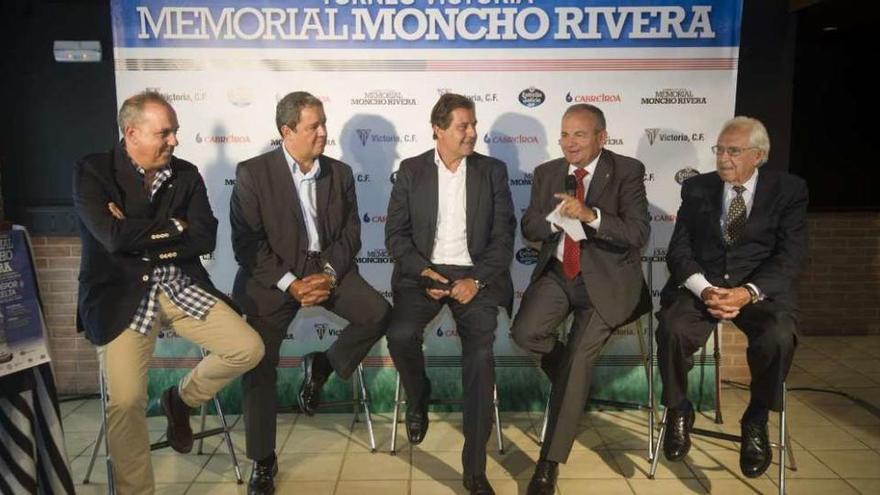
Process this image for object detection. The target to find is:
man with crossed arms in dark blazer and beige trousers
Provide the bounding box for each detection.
[73,92,263,494]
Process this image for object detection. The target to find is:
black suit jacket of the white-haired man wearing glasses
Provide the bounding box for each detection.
[662,170,808,309]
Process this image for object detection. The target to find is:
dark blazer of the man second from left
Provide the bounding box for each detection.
[229,146,361,315]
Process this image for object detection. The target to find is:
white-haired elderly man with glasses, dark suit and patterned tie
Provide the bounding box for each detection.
[657,117,807,477]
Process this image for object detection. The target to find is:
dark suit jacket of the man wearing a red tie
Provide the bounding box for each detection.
[522,149,651,327]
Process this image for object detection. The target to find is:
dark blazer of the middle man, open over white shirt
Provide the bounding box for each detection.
[385,149,516,313]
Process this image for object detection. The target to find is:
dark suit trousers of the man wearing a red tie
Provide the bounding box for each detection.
[511,260,613,462]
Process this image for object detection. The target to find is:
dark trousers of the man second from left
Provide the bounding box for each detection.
[242,269,391,460]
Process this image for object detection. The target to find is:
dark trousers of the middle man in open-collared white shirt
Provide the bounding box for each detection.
[387,266,498,477]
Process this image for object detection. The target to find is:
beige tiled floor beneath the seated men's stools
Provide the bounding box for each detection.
[62,336,880,495]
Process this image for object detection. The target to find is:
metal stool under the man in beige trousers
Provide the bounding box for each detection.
[83,348,244,495]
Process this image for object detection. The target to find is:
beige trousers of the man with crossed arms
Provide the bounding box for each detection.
[98,291,263,495]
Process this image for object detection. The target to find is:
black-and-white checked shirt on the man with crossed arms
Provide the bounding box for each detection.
[128,162,217,335]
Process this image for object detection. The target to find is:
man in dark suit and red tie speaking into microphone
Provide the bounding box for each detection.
[511,104,651,494]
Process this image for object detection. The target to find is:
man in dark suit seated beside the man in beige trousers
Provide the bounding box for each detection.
[230,92,390,494]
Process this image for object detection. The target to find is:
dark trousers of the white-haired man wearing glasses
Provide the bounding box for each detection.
[657,288,797,411]
